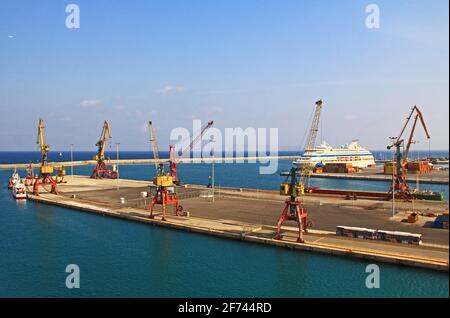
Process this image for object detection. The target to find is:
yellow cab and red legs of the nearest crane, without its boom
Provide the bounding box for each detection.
[275,167,312,243]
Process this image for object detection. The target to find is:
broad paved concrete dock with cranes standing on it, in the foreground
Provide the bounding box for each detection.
[25,176,449,271]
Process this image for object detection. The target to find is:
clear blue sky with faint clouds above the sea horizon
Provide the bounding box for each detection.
[0,0,449,150]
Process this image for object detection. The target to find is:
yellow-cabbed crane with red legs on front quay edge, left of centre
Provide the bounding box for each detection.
[148,121,183,221]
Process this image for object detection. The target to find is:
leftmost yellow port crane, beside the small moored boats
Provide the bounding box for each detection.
[30,118,57,195]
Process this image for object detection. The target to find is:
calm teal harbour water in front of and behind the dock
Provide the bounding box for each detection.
[0,152,449,297]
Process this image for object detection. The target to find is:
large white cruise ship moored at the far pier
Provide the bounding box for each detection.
[294,140,375,168]
